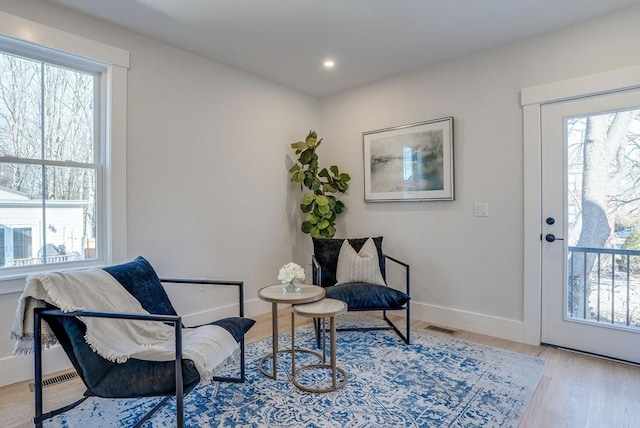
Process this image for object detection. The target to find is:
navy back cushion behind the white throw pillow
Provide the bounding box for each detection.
[312,236,386,287]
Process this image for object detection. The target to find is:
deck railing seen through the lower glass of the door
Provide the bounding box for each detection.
[567,247,640,329]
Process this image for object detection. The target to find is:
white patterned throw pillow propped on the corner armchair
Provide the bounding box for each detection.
[336,238,386,285]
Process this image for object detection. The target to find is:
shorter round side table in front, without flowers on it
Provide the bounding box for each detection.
[291,299,347,392]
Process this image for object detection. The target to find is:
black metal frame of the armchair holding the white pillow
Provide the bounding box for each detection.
[311,254,411,348]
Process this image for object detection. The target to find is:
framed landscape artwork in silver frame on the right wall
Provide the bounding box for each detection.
[362,117,454,202]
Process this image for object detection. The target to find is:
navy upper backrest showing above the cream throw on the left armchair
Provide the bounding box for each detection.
[104,257,177,315]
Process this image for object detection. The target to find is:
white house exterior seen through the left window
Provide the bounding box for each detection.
[0,187,95,268]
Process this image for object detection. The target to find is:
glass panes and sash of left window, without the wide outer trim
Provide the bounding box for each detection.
[0,46,104,268]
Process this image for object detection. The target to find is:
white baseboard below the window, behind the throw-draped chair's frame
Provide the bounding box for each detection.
[0,346,71,387]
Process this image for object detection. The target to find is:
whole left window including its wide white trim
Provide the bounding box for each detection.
[0,12,129,278]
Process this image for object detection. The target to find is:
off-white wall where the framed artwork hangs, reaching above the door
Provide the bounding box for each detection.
[320,7,640,341]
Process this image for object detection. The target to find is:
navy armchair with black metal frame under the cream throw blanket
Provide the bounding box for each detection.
[34,257,255,427]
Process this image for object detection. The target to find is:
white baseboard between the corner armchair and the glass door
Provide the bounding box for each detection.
[411,302,528,345]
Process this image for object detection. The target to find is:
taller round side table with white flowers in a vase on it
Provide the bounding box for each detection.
[258,284,324,379]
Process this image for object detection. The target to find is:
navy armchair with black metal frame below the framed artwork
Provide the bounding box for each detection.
[312,236,411,344]
